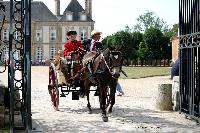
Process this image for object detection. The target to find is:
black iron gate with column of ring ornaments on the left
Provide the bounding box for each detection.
[0,0,32,133]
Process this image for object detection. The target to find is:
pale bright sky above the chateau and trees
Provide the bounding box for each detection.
[39,0,179,36]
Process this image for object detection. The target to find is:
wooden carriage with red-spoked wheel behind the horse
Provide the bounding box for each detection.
[48,53,84,110]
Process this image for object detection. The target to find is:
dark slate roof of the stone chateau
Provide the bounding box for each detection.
[0,0,94,22]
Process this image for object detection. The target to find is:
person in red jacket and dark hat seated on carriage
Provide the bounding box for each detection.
[64,31,84,57]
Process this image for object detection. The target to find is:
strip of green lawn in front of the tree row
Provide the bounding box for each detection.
[120,67,171,79]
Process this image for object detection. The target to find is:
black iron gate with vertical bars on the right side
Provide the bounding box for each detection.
[179,0,200,121]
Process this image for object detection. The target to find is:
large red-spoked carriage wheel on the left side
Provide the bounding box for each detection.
[48,63,59,111]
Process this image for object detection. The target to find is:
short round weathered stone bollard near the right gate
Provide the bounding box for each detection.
[156,84,172,111]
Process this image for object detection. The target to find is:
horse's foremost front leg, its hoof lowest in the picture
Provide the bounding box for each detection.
[99,87,108,122]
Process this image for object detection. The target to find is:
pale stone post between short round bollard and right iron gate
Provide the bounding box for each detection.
[172,76,180,111]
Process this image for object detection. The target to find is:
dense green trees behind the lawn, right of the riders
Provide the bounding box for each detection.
[102,11,179,64]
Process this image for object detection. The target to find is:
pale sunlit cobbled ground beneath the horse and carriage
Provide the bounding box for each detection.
[0,66,200,133]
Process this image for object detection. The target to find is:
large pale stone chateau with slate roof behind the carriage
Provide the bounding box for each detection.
[0,0,95,64]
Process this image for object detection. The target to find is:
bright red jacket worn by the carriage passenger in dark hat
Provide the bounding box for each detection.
[64,40,84,56]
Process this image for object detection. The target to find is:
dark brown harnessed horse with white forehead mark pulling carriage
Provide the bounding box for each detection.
[81,46,123,122]
